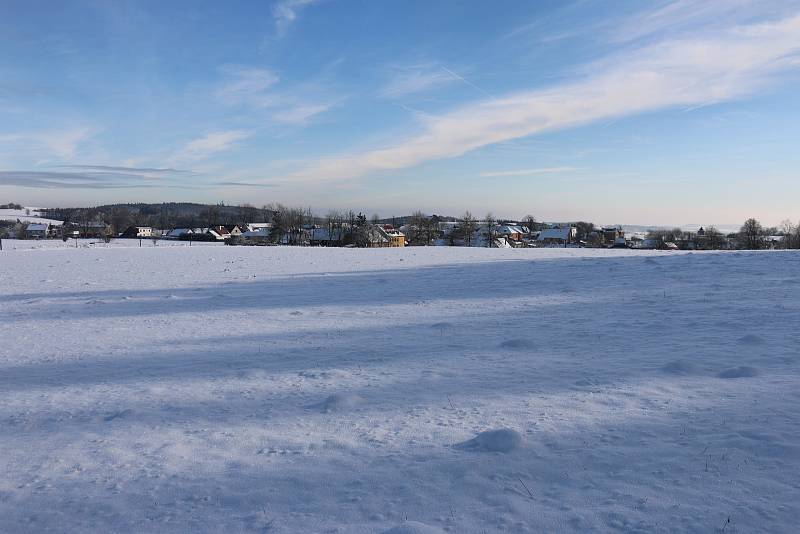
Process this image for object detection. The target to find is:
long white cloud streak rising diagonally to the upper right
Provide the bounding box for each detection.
[285,15,800,186]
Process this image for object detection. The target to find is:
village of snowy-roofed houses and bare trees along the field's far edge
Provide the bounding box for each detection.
[0,204,800,250]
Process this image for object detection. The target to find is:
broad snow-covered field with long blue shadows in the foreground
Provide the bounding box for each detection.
[0,247,800,533]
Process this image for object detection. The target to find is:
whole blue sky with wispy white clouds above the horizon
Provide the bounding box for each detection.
[0,0,800,224]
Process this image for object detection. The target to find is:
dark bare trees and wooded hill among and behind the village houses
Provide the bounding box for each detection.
[9,202,800,250]
